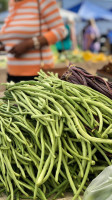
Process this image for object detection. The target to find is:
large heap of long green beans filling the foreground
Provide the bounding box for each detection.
[0,71,112,200]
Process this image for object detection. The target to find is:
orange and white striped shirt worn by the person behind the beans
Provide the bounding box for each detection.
[0,0,66,76]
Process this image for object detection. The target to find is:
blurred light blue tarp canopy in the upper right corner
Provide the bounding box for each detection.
[78,1,112,20]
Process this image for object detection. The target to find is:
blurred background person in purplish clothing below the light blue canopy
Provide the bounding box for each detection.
[83,19,100,52]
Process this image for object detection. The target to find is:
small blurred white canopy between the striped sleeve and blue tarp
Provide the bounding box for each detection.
[60,9,78,20]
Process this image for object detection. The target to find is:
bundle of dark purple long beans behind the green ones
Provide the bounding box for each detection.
[61,65,112,99]
